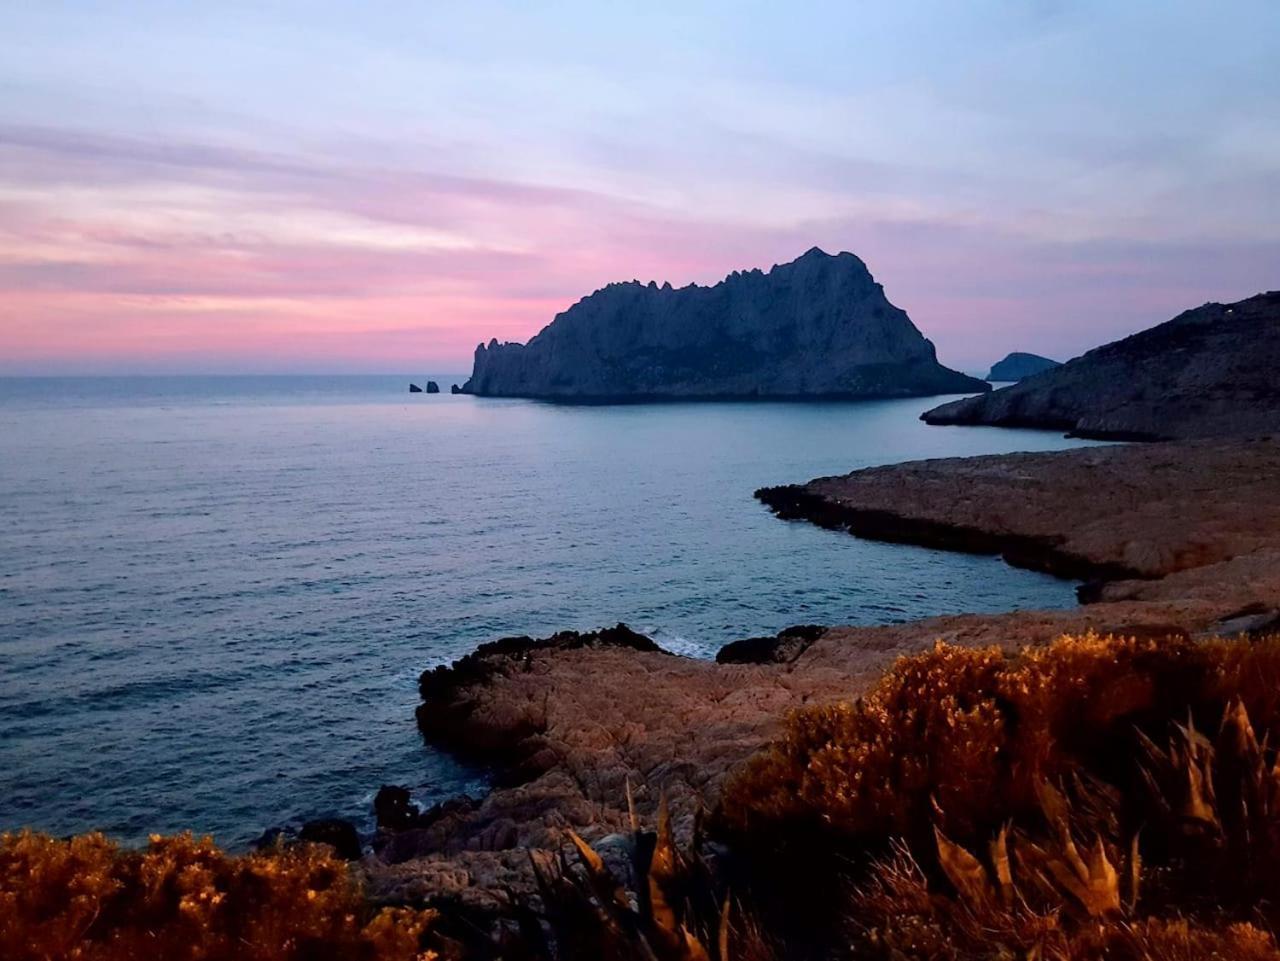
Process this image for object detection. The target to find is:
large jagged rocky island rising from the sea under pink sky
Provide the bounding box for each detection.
[463,248,989,401]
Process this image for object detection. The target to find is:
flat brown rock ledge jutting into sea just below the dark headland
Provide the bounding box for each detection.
[755,438,1280,598]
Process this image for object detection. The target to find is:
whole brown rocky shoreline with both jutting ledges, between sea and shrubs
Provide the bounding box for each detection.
[362,439,1280,915]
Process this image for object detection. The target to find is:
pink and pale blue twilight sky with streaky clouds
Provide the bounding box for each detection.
[0,0,1280,375]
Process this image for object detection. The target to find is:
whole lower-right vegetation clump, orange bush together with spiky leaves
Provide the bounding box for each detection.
[719,635,1280,961]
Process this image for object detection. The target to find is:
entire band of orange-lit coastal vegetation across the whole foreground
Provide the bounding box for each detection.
[0,633,1280,961]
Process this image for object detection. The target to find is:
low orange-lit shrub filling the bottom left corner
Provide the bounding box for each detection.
[0,832,436,961]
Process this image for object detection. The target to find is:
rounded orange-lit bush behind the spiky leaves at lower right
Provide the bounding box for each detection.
[721,635,1213,839]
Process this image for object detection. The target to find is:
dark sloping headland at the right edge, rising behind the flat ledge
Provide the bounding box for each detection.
[923,292,1280,440]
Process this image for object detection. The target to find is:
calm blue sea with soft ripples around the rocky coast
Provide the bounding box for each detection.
[0,375,1100,845]
